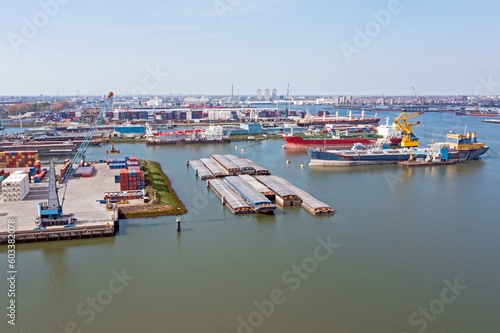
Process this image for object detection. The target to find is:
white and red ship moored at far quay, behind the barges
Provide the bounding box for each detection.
[146,124,231,145]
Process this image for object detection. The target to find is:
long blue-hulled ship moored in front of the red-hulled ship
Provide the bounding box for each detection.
[307,132,489,166]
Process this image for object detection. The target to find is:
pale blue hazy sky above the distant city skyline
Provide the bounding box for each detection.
[0,0,500,96]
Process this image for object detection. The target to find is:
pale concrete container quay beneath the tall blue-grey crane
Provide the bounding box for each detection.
[0,163,119,244]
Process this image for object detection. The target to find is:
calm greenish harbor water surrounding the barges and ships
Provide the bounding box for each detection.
[0,114,500,333]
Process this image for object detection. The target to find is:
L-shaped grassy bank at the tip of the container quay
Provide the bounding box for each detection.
[118,160,187,219]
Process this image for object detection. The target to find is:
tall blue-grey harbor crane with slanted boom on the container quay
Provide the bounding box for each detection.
[35,92,114,227]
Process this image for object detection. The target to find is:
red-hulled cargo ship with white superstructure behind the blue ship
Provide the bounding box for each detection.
[282,118,402,149]
